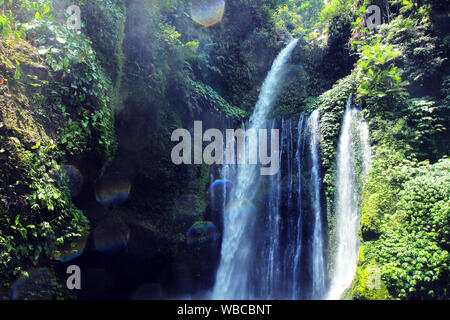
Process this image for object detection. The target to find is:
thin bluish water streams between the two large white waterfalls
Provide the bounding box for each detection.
[254,111,327,299]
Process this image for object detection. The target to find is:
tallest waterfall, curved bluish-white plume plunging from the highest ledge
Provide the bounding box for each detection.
[213,40,298,299]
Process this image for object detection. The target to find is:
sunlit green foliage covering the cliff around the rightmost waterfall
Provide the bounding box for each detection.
[319,1,449,299]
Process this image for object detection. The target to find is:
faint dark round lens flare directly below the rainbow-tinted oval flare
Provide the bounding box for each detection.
[93,220,130,254]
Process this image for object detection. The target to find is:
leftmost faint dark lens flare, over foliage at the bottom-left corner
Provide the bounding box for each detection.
[11,268,56,300]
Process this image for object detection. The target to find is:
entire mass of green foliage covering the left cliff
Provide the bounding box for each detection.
[0,1,122,298]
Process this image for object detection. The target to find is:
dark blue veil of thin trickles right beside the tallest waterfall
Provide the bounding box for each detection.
[255,119,297,299]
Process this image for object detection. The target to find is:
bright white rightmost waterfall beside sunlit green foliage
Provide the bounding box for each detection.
[328,96,371,300]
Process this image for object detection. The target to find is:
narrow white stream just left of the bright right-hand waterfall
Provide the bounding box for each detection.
[308,110,326,299]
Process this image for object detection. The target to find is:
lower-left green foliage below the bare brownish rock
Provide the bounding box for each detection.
[0,132,89,298]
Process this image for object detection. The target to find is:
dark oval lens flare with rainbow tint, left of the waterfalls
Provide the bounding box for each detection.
[95,177,131,206]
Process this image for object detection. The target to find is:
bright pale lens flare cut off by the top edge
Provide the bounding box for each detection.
[191,0,225,28]
